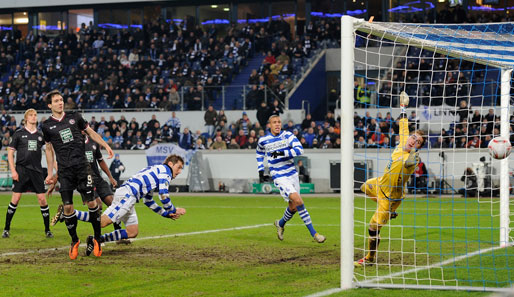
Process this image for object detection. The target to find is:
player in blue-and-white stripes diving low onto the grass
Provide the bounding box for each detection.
[69,155,186,242]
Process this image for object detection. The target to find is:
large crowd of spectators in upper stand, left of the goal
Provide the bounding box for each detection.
[0,20,310,110]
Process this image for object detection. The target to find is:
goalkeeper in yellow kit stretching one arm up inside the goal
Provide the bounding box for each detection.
[354,92,425,267]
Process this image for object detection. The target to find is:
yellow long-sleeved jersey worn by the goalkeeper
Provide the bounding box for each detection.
[378,118,419,200]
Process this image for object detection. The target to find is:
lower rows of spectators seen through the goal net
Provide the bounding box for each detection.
[354,101,514,149]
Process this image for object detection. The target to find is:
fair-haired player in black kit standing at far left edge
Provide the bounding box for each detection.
[2,108,54,238]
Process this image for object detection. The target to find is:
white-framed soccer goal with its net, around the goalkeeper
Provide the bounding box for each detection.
[341,16,514,291]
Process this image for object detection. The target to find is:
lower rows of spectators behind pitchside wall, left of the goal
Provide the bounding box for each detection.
[0,101,341,150]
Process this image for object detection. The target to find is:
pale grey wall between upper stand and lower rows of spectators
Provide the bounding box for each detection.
[10,109,305,133]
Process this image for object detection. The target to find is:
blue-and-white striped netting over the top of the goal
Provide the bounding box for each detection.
[356,20,514,68]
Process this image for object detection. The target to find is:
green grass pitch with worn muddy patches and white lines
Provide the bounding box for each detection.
[0,194,504,296]
